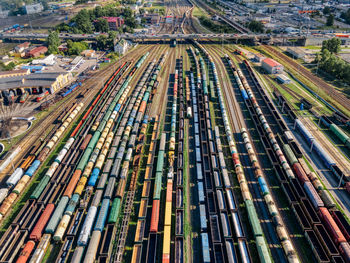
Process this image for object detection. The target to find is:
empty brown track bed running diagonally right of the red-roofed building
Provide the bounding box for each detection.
[263,45,350,116]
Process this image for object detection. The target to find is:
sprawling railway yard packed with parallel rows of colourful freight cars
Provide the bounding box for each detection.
[0,0,350,263]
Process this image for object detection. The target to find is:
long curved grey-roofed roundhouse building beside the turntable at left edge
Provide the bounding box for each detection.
[0,69,72,95]
